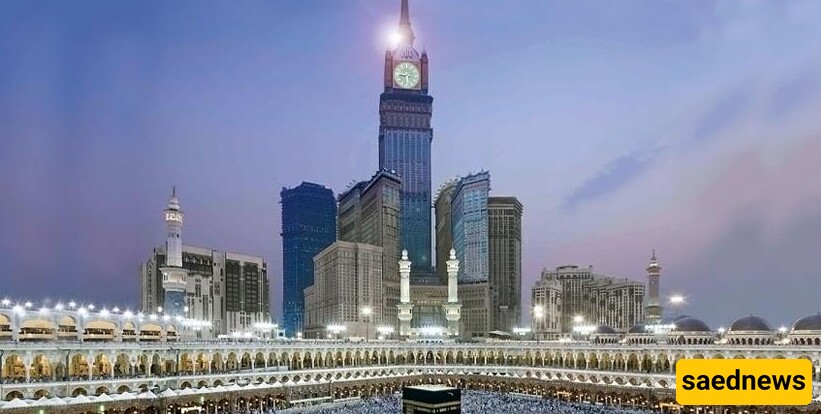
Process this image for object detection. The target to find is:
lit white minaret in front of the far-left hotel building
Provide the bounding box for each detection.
[159,188,188,317]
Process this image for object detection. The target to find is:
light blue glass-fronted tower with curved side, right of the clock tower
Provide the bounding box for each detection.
[451,172,490,283]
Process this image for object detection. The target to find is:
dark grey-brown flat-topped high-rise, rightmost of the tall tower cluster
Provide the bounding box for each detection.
[488,197,522,332]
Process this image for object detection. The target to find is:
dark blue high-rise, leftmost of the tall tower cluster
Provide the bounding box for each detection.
[280,182,336,336]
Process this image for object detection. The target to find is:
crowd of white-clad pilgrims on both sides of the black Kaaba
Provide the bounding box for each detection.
[265,391,650,414]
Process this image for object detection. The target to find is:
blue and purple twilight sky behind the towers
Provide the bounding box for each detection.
[0,0,821,328]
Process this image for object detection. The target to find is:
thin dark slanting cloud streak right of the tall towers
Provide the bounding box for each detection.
[561,148,662,211]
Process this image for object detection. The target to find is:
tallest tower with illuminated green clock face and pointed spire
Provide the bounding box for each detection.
[379,0,436,283]
